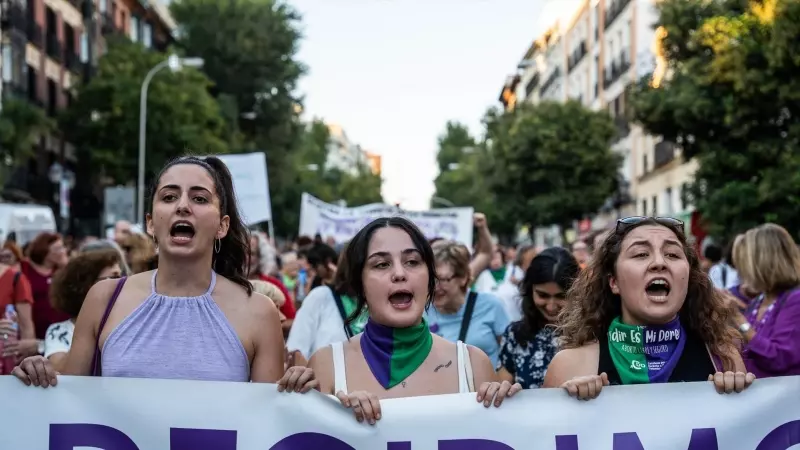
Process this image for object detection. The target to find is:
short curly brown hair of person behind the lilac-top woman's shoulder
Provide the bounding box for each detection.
[50,248,122,319]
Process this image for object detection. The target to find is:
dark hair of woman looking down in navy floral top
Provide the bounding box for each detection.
[511,247,581,345]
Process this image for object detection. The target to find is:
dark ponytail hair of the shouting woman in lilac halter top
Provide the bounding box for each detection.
[150,156,253,295]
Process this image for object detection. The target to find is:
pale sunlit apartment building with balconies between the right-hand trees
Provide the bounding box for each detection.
[500,0,696,243]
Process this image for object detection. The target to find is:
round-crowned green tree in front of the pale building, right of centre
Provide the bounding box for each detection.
[486,101,622,241]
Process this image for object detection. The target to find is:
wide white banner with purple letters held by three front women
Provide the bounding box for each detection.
[0,377,800,450]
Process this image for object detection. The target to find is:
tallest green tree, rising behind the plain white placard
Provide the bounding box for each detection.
[170,0,306,235]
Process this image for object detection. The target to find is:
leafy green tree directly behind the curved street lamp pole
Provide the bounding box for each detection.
[59,39,228,182]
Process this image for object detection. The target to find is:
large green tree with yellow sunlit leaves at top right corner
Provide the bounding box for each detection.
[631,0,800,238]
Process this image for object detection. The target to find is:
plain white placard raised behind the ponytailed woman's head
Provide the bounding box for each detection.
[217,152,272,226]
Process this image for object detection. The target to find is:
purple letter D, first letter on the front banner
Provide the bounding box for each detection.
[48,423,139,450]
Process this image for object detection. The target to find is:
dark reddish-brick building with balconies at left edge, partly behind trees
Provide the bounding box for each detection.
[0,0,175,231]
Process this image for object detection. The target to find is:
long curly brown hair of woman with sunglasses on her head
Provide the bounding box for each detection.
[558,218,738,370]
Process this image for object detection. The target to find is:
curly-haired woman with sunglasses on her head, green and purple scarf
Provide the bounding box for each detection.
[544,217,755,400]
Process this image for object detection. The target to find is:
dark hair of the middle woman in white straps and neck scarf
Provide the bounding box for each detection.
[343,217,436,325]
